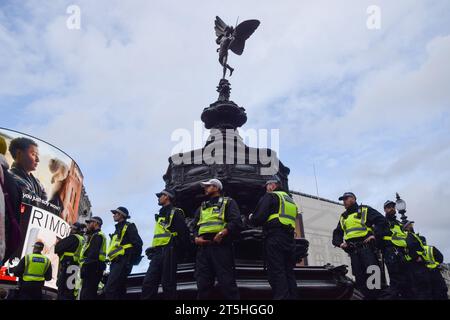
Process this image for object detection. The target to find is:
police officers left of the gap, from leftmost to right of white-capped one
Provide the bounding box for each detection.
[13,179,298,300]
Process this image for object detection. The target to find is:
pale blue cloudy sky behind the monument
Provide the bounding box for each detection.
[0,0,450,261]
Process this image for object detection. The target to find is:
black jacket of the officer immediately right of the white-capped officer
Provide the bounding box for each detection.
[250,189,294,234]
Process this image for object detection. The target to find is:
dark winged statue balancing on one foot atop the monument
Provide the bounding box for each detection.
[214,16,260,79]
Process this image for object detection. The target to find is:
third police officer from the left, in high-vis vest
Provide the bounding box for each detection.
[80,217,107,300]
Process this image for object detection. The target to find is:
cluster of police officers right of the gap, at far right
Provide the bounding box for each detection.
[332,192,448,300]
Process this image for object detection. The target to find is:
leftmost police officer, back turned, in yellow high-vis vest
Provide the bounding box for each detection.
[13,241,52,300]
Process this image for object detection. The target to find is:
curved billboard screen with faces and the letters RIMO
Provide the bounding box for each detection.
[0,128,83,288]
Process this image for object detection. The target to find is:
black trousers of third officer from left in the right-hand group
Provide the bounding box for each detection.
[407,262,432,300]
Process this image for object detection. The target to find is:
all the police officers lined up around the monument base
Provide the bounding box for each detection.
[8,179,447,300]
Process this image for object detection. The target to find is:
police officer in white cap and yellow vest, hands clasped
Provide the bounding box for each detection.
[193,179,242,300]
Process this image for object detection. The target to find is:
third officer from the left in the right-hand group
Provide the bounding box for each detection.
[404,221,432,300]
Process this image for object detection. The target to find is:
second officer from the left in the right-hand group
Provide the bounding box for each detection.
[383,200,411,300]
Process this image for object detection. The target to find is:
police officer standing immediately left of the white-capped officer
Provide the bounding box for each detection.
[141,189,189,300]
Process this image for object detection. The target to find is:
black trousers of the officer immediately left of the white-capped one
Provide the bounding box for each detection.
[141,244,177,300]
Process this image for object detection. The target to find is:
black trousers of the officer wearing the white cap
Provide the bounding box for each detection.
[195,243,239,300]
